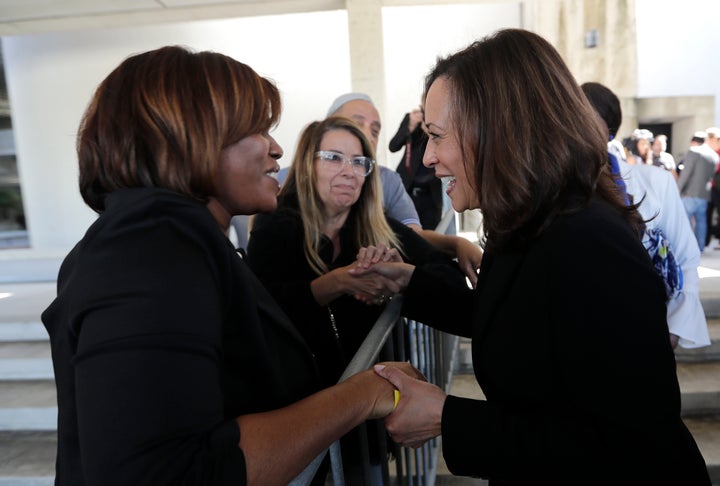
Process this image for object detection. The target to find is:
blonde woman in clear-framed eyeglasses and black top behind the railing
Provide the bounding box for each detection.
[247,117,465,385]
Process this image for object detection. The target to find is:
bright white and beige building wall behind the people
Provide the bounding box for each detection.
[3,0,720,253]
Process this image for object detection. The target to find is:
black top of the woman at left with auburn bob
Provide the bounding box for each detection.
[42,189,317,486]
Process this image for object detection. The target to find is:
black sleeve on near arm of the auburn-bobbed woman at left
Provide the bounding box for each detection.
[73,213,246,485]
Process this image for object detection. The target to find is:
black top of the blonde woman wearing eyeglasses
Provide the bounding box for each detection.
[247,197,467,385]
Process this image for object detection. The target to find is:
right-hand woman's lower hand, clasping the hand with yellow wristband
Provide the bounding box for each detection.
[375,363,447,448]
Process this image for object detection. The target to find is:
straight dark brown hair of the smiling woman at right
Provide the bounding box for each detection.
[425,29,643,249]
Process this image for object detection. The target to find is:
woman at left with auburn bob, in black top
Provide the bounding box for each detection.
[42,47,413,486]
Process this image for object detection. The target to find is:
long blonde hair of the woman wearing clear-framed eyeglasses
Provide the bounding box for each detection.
[279,116,402,275]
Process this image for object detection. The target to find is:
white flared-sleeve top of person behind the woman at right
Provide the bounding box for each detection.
[618,161,710,348]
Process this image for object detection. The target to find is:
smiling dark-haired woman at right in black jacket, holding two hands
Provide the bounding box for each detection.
[358,29,710,485]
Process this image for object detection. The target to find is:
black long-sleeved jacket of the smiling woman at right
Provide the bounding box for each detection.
[404,198,710,485]
